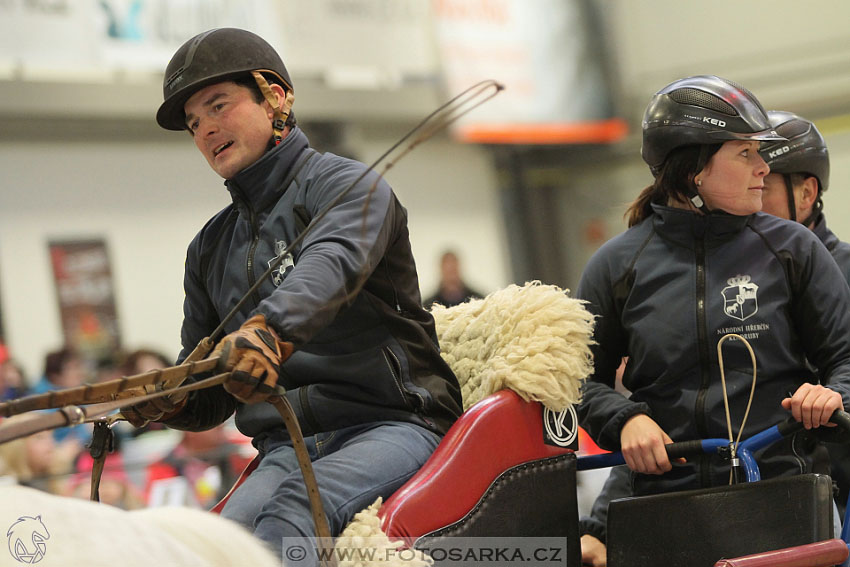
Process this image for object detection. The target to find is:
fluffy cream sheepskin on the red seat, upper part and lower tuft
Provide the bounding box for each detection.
[335,281,593,567]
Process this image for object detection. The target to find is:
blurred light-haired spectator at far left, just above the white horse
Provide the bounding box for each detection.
[0,428,79,494]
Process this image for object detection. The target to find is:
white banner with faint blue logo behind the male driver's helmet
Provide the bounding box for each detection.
[0,0,281,73]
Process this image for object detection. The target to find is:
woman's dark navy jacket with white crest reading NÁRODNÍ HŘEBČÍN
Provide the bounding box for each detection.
[577,205,850,494]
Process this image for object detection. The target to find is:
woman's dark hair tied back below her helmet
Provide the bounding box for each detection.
[625,144,723,227]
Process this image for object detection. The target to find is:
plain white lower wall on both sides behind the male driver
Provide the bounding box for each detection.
[0,131,506,376]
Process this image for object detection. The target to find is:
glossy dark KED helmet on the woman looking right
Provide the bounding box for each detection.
[641,75,784,173]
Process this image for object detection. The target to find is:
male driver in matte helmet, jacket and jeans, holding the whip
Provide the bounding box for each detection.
[124,29,461,565]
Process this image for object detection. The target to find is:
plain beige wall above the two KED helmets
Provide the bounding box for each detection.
[598,0,850,120]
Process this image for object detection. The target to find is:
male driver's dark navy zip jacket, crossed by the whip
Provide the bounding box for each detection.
[167,128,461,444]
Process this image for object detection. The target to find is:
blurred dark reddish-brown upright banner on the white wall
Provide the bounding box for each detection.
[48,239,121,361]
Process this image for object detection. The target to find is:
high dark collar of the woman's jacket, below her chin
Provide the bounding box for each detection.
[652,204,752,247]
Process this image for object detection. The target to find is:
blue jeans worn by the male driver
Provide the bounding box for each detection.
[221,421,440,567]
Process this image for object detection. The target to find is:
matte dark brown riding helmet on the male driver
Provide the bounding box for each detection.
[156,28,293,130]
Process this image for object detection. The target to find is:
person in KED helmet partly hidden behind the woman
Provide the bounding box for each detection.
[759,110,850,517]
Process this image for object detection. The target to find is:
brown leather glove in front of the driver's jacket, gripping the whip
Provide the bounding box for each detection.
[210,314,293,404]
